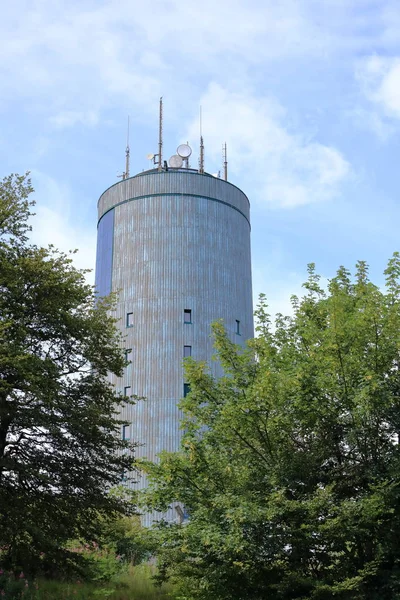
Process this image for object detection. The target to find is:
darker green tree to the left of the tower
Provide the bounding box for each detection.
[0,175,136,572]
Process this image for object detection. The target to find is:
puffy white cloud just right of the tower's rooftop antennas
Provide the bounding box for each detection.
[182,83,350,208]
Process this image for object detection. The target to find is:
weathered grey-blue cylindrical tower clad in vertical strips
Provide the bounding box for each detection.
[96,169,254,525]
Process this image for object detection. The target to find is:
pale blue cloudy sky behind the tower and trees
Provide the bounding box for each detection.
[0,0,400,312]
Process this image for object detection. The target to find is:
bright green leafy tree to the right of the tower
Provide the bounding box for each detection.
[142,254,400,600]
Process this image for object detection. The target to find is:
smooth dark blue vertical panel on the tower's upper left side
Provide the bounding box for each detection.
[95,210,114,296]
